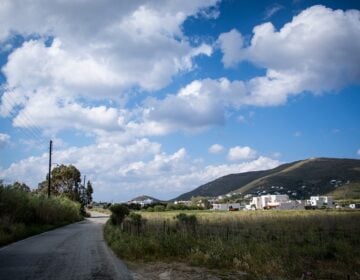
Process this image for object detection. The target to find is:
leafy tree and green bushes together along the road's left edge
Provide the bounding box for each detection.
[0,165,93,246]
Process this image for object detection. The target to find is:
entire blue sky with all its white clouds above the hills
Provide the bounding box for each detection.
[0,0,360,202]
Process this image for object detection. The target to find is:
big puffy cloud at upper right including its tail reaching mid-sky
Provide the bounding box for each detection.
[141,5,360,133]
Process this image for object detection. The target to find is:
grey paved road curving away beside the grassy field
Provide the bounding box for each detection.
[0,214,131,280]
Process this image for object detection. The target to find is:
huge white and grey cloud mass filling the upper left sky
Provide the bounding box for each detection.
[0,0,217,135]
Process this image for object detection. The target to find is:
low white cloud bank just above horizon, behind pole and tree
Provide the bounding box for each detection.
[0,139,280,201]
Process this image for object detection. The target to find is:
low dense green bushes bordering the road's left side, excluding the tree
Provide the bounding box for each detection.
[0,185,82,246]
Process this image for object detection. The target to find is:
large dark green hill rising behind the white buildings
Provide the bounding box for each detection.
[174,158,360,200]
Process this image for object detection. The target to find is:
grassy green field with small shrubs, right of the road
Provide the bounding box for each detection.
[104,210,360,279]
